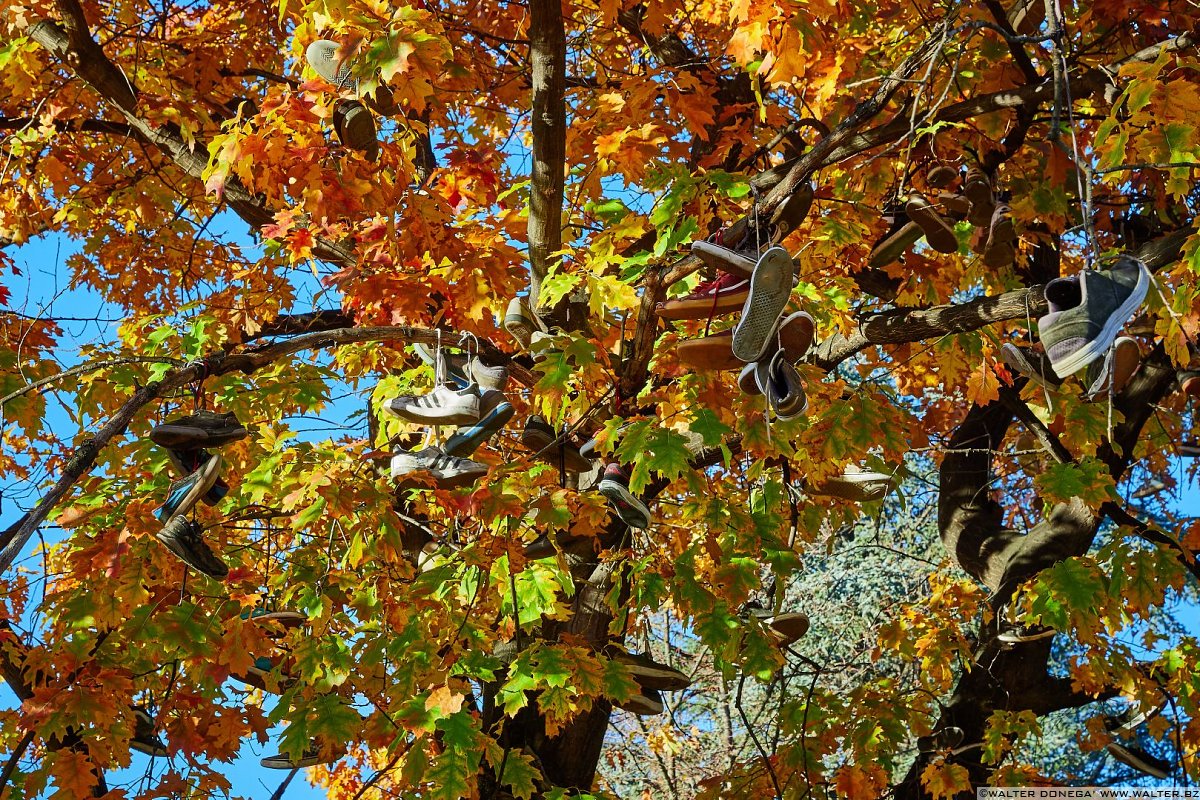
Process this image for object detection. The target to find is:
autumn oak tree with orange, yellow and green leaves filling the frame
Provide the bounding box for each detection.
[0,0,1200,798]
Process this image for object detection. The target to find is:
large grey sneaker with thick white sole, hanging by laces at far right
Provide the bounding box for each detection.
[1038,255,1150,378]
